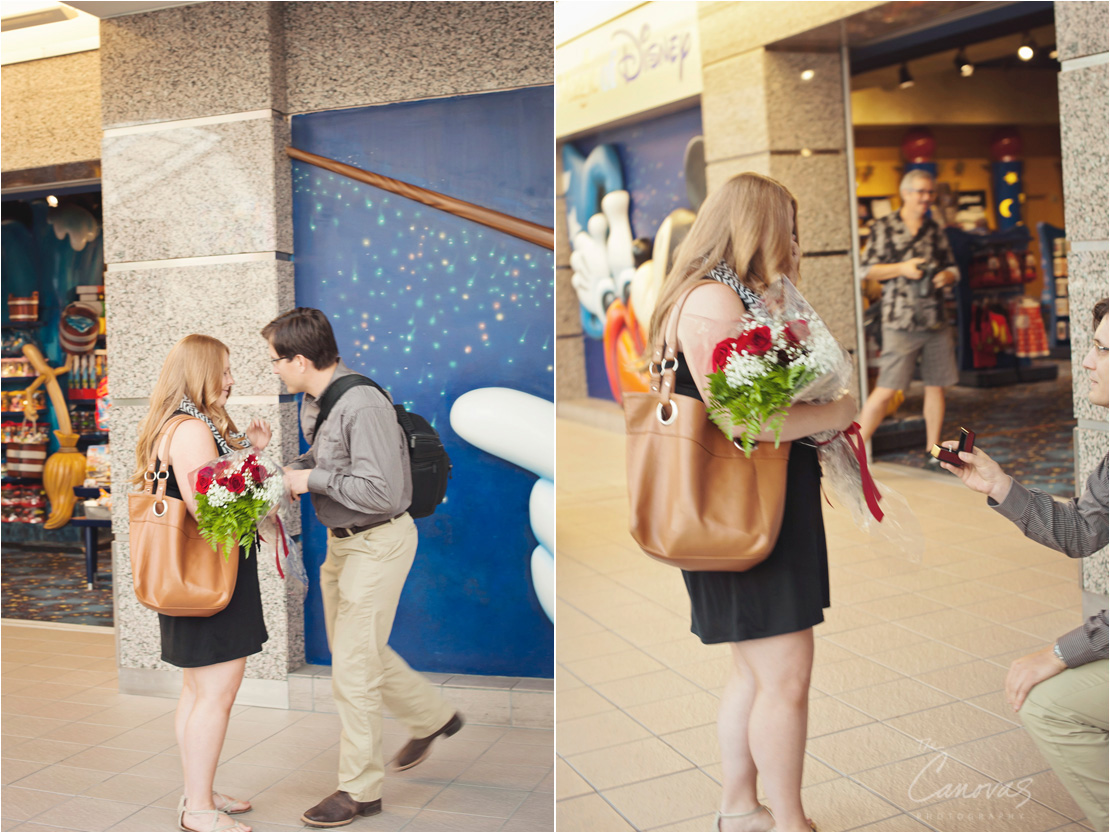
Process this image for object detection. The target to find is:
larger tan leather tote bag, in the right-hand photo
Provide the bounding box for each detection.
[624,284,790,572]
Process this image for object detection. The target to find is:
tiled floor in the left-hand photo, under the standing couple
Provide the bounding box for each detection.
[0,622,554,832]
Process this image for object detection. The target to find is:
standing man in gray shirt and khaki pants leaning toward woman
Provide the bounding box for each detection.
[262,307,463,828]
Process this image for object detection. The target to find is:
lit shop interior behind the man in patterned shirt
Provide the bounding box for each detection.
[851,3,1074,488]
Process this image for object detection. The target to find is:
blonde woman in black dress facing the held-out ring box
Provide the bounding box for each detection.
[650,173,856,832]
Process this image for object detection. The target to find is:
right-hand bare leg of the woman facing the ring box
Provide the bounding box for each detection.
[722,629,814,832]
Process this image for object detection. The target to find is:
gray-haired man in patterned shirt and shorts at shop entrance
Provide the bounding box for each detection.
[856,171,959,461]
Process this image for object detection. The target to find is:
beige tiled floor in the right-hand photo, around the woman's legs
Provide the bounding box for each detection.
[555,419,1088,832]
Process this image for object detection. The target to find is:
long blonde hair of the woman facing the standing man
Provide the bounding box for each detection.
[131,335,242,485]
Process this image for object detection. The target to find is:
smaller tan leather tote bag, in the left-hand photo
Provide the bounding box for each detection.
[128,416,239,618]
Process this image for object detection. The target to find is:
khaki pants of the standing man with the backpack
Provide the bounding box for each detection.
[320,514,454,802]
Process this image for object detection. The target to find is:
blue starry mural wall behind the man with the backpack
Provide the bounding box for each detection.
[292,87,555,678]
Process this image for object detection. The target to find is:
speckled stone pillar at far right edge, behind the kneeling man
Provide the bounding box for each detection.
[1056,2,1110,615]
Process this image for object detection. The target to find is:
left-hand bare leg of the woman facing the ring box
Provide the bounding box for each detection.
[717,645,774,832]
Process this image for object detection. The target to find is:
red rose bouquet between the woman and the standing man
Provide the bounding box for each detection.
[193,449,286,557]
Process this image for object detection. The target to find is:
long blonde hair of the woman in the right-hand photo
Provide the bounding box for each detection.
[647,172,798,350]
